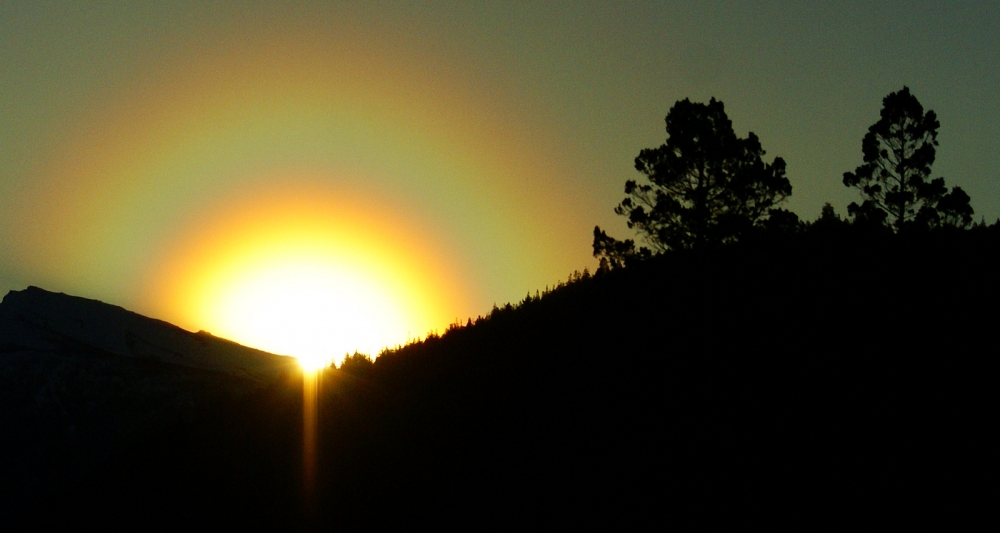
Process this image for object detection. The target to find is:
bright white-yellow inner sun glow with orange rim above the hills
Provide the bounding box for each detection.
[148,183,462,370]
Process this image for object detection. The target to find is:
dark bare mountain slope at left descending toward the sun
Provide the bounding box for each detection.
[0,287,297,513]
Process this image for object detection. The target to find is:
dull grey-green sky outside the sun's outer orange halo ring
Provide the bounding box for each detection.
[0,0,1000,302]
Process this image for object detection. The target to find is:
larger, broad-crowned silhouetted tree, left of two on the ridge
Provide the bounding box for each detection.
[594,98,792,266]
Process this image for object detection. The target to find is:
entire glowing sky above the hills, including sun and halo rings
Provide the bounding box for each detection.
[0,0,1000,360]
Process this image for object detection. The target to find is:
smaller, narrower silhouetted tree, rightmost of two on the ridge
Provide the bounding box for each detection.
[844,86,973,231]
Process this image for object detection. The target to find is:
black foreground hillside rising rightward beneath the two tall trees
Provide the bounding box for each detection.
[0,231,1000,530]
